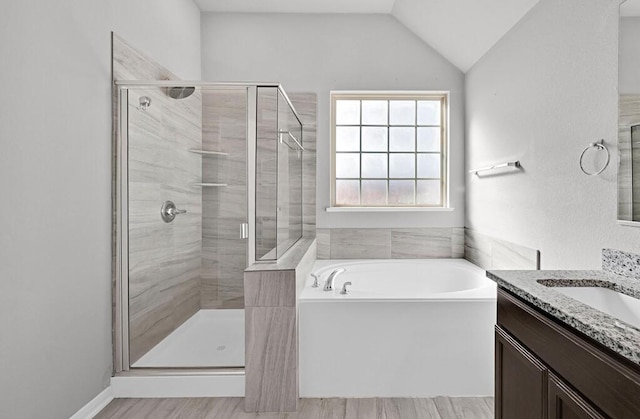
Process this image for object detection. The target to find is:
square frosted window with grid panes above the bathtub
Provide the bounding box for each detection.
[331,92,448,208]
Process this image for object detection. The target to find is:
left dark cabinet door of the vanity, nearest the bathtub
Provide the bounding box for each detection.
[495,326,547,419]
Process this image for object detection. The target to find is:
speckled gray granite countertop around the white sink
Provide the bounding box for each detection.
[487,270,640,365]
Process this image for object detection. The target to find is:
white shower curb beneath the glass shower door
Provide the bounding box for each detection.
[111,374,245,399]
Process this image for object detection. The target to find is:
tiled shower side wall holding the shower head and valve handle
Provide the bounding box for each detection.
[113,35,202,363]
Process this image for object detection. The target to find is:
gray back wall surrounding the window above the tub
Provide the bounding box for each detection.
[202,13,464,228]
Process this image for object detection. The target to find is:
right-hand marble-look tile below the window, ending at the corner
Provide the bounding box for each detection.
[391,228,452,259]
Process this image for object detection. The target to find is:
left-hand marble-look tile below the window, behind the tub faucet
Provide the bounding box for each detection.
[330,228,391,259]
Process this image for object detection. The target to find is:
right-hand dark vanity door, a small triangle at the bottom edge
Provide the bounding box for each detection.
[548,373,604,419]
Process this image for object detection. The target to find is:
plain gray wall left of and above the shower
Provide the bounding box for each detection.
[0,0,200,418]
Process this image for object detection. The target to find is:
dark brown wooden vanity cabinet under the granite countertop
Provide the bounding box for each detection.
[495,289,640,419]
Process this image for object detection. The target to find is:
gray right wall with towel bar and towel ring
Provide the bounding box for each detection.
[465,0,640,269]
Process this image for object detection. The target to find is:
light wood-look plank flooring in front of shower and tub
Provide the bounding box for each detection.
[96,397,494,419]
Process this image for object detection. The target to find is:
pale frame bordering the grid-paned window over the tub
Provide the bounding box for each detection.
[327,90,451,211]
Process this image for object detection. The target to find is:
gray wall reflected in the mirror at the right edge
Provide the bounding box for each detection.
[619,16,640,94]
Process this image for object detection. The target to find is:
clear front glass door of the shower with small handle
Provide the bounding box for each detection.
[120,86,248,368]
